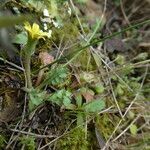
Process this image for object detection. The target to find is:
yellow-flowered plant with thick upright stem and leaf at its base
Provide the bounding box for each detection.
[22,22,51,110]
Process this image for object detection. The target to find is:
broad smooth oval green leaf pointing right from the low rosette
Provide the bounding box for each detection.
[83,100,105,113]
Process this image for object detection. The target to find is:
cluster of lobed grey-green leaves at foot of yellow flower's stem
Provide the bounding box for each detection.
[28,66,71,110]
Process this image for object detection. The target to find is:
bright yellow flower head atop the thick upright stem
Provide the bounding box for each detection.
[24,22,51,40]
